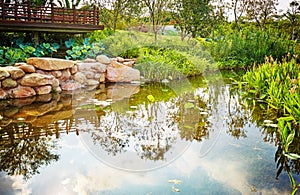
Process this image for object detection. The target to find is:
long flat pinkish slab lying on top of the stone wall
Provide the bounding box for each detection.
[26,57,75,70]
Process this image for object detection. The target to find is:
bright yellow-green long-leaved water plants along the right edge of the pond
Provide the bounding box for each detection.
[243,58,300,194]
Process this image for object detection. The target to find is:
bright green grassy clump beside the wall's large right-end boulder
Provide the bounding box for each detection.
[136,47,208,81]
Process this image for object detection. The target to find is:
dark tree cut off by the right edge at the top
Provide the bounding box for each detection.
[284,1,300,40]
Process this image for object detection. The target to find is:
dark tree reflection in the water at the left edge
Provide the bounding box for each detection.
[0,123,59,179]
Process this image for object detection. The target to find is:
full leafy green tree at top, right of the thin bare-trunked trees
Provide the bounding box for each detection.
[173,0,212,40]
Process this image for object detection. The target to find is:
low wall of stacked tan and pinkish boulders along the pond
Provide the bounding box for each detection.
[0,55,140,99]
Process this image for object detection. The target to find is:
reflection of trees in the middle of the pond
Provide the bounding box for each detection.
[91,89,209,161]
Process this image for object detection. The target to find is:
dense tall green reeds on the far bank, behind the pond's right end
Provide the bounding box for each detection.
[207,27,296,68]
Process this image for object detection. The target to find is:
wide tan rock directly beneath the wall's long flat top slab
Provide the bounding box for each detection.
[19,73,56,87]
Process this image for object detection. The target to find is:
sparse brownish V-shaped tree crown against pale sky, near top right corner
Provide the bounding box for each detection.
[245,0,278,30]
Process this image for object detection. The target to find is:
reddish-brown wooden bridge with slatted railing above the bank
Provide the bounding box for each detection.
[0,0,103,33]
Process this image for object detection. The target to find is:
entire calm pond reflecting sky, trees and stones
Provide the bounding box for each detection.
[0,73,299,194]
